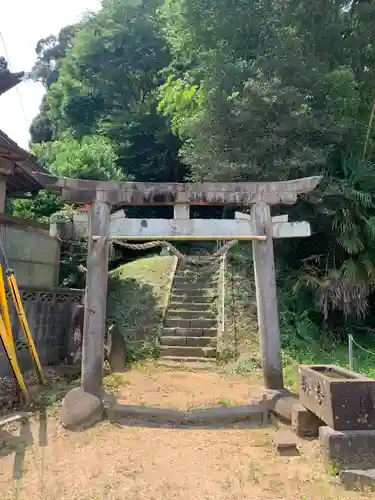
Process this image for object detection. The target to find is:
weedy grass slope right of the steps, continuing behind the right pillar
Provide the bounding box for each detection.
[224,252,375,390]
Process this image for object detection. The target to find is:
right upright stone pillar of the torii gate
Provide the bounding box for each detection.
[251,201,284,389]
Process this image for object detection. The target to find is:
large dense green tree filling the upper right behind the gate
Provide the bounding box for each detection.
[160,0,373,180]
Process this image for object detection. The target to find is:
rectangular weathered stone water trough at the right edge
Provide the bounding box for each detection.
[299,365,375,430]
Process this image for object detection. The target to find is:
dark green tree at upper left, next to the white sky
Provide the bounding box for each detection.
[34,0,184,181]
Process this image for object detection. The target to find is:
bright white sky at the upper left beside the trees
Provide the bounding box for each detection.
[0,0,100,149]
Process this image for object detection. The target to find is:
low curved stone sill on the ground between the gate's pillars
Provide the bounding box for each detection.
[108,404,264,426]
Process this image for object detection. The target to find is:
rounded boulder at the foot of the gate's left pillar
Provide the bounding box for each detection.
[60,387,104,430]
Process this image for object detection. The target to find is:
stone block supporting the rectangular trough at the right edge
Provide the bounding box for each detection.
[319,426,375,470]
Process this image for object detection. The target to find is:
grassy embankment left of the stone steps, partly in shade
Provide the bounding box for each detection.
[107,256,175,362]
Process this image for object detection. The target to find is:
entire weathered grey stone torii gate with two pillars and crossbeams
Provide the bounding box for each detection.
[34,173,321,397]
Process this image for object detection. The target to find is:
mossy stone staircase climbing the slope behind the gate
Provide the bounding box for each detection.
[160,263,217,362]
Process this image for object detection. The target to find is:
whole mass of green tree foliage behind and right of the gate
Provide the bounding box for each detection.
[18,0,375,332]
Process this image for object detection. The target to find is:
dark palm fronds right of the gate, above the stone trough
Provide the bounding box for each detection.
[296,156,375,319]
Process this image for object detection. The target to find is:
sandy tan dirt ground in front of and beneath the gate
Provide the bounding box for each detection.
[0,367,374,500]
